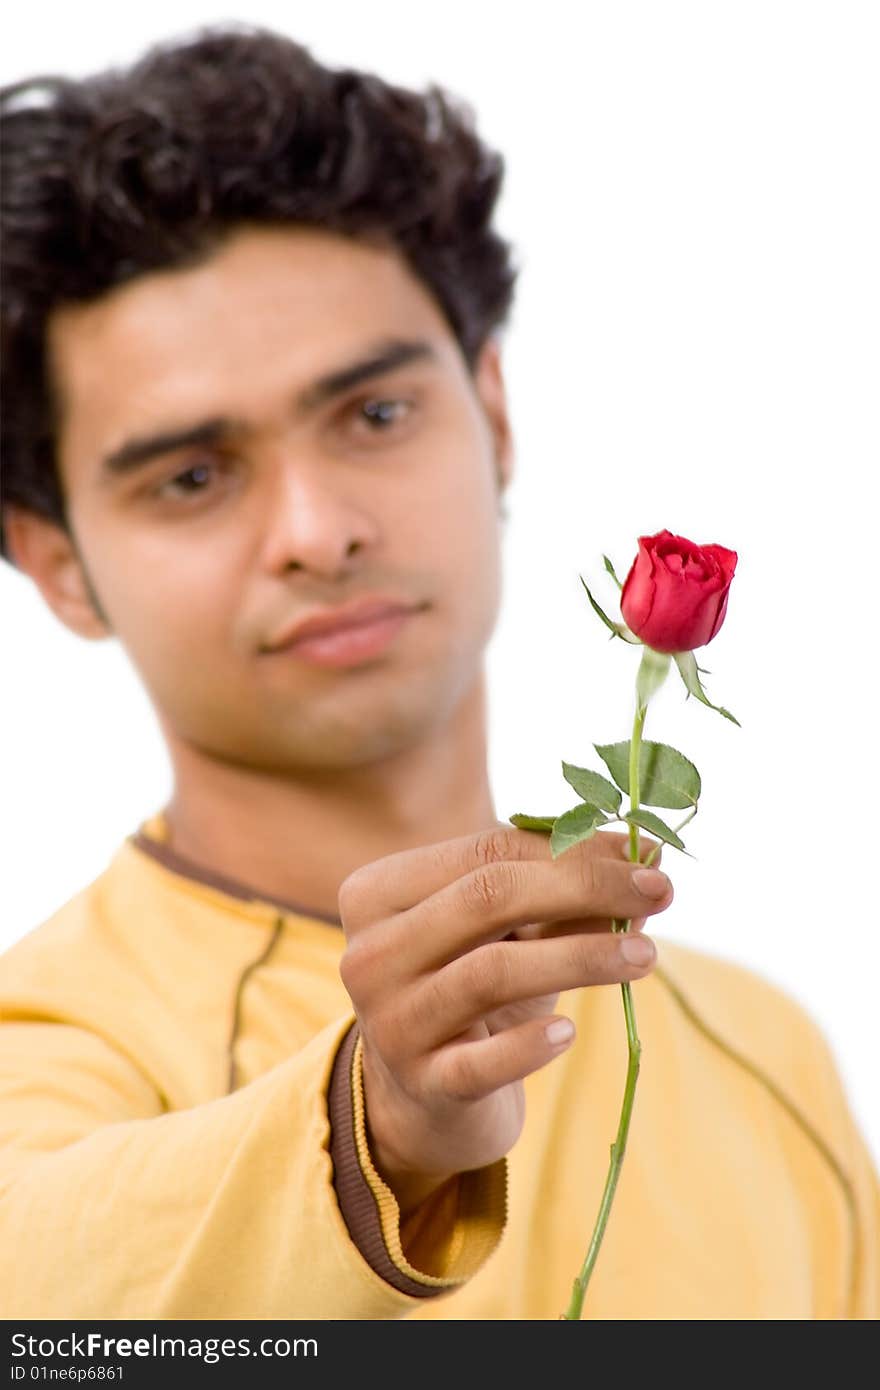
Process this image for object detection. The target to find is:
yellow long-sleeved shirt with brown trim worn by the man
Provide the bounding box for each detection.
[0,815,880,1319]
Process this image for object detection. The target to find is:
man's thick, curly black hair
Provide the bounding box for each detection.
[0,24,519,560]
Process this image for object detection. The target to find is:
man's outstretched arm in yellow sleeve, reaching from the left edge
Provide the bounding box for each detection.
[0,1017,503,1319]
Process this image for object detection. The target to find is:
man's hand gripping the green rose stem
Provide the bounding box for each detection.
[339,824,664,1215]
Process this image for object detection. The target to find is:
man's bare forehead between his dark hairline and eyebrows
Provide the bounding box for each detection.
[47,228,459,450]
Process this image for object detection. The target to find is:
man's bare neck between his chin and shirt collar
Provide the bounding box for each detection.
[159,671,498,916]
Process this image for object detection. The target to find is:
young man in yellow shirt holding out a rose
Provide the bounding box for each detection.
[0,29,880,1319]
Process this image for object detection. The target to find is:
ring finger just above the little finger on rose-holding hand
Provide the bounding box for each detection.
[393,933,656,1055]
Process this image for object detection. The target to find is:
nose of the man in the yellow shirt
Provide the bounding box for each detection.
[255,457,378,577]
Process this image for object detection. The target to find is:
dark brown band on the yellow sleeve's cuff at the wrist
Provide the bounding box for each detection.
[328,1023,445,1298]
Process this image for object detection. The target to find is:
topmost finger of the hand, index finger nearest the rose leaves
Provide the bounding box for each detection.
[338,821,631,934]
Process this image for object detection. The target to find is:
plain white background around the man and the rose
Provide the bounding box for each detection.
[0,0,880,1158]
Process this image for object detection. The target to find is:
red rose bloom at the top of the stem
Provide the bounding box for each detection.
[620,531,737,652]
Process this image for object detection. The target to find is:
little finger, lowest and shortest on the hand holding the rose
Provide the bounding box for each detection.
[425,1015,574,1102]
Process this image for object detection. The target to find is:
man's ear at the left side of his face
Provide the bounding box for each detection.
[3,506,110,641]
